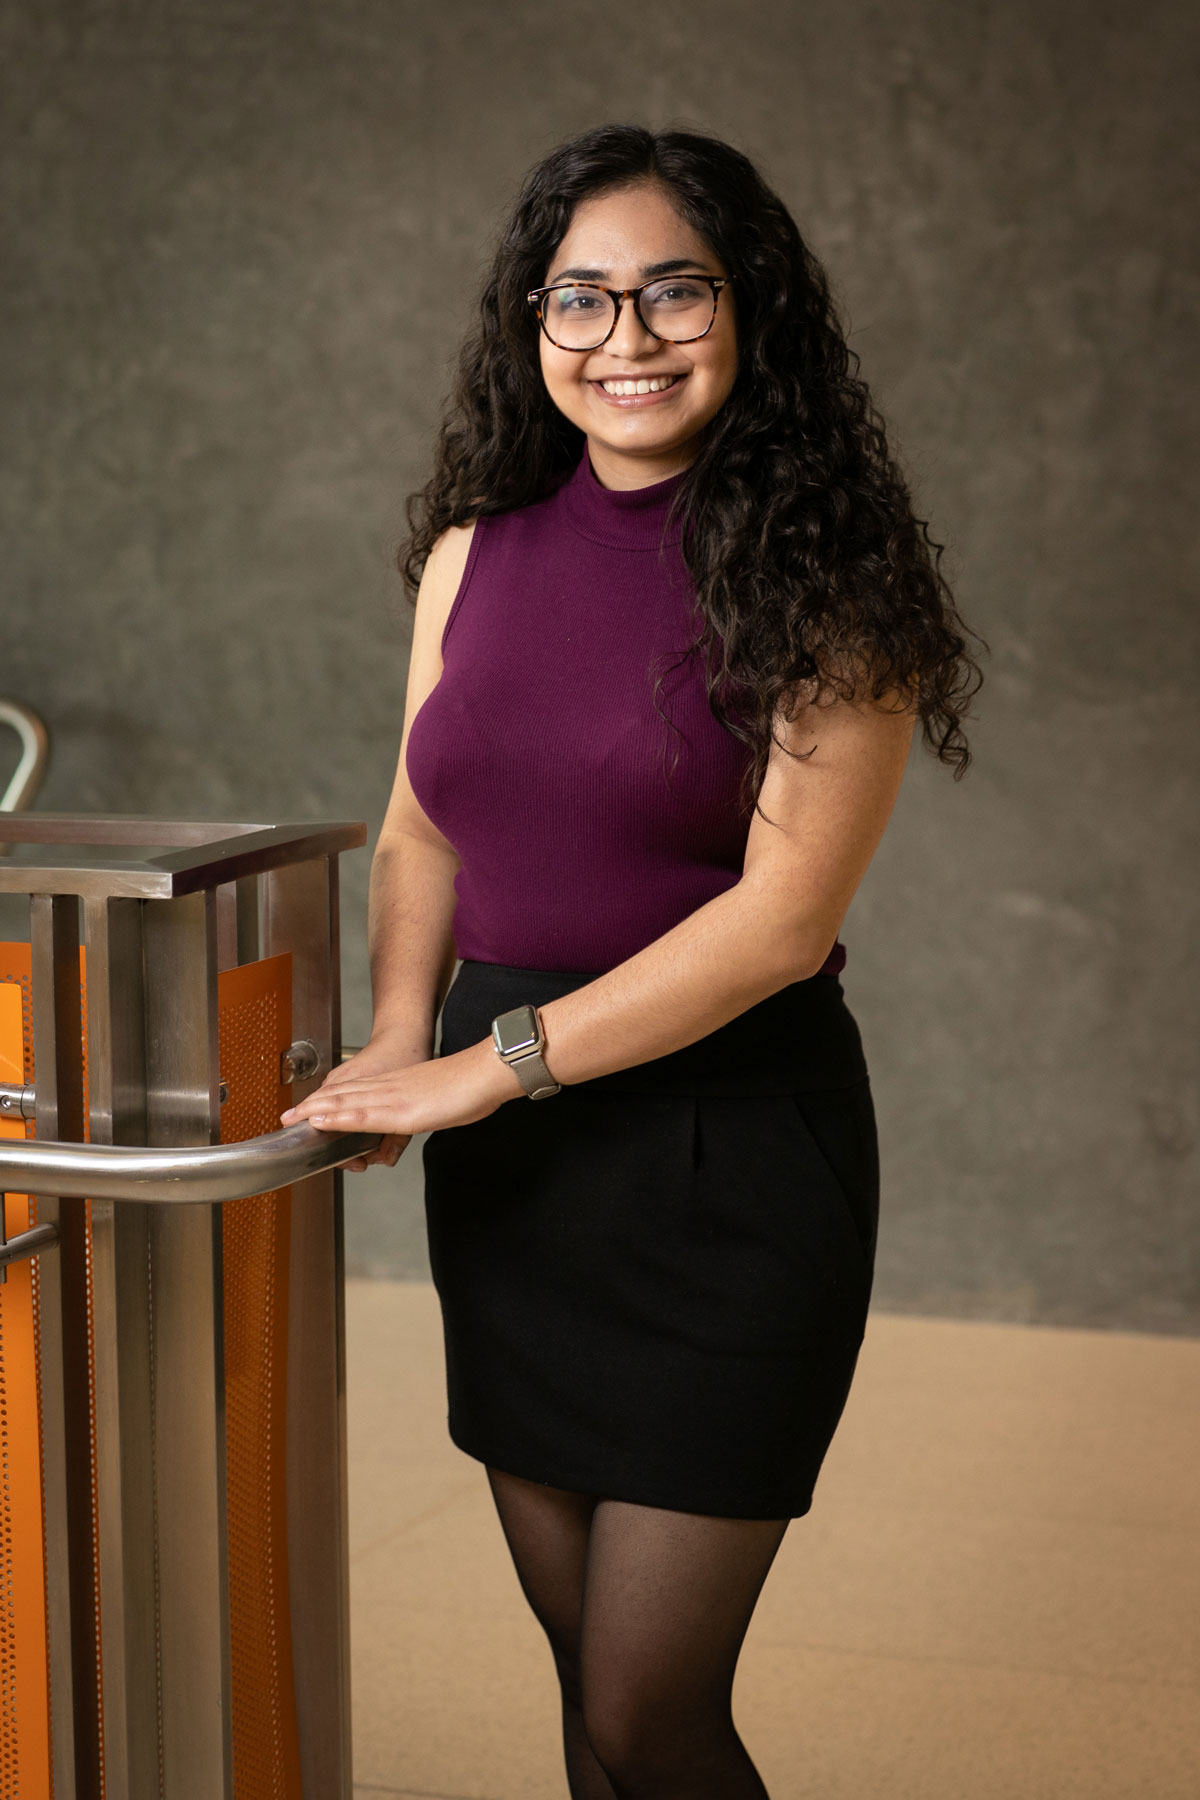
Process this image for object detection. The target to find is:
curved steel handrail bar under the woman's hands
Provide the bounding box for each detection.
[0,1123,380,1206]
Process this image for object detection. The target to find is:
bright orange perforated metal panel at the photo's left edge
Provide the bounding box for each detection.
[0,943,52,1800]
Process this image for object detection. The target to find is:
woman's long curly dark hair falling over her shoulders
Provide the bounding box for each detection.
[398,124,988,803]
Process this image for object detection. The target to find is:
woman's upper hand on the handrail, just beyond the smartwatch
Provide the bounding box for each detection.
[281,1039,524,1138]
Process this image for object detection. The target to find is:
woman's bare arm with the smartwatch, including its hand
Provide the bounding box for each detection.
[286,676,916,1132]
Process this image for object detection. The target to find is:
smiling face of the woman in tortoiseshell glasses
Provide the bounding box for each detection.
[538,182,738,488]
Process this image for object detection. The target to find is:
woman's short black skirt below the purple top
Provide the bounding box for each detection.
[423,961,880,1519]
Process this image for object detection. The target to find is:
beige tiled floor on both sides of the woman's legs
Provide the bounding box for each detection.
[349,1282,1200,1800]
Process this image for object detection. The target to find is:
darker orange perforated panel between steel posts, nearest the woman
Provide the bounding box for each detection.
[218,956,300,1800]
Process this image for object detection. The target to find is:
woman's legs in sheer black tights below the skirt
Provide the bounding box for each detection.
[488,1469,788,1800]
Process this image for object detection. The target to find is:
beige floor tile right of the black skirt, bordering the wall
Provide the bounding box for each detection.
[820,1314,1200,1530]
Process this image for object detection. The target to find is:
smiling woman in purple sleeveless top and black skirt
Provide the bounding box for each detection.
[284,126,979,1800]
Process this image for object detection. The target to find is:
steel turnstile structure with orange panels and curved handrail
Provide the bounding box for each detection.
[0,814,378,1800]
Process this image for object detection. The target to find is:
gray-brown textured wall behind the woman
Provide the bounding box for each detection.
[0,0,1200,1330]
